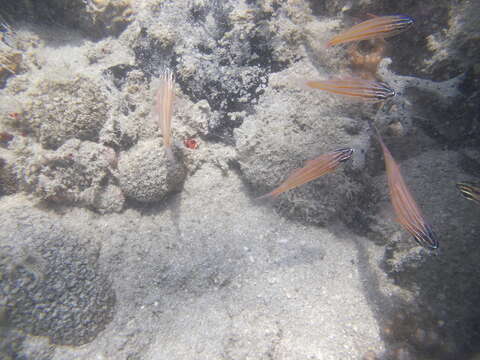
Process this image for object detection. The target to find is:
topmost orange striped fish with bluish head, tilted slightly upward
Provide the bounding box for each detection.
[327,15,415,47]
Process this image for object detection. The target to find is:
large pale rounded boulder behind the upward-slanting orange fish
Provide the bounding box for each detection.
[235,63,372,224]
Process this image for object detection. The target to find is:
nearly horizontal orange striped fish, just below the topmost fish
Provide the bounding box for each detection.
[306,79,395,102]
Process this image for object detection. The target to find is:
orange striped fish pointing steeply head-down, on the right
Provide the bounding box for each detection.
[375,128,438,249]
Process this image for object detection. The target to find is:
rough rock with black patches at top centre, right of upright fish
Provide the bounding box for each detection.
[131,1,302,139]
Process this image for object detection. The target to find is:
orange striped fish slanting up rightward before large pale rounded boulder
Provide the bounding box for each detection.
[258,148,353,199]
